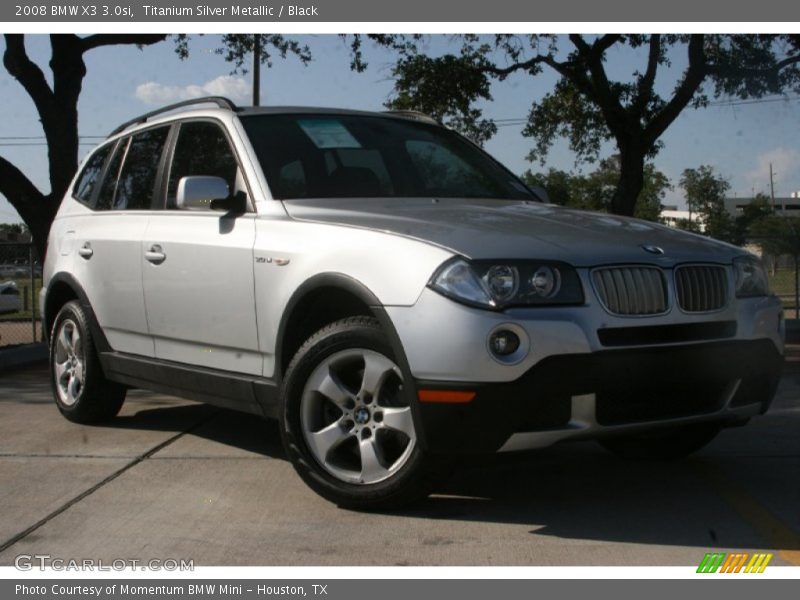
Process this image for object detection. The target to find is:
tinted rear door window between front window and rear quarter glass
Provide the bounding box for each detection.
[112,127,169,210]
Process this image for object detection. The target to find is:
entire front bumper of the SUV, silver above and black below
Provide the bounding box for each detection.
[386,289,784,454]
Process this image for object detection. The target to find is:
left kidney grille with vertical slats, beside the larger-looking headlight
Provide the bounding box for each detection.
[592,266,667,316]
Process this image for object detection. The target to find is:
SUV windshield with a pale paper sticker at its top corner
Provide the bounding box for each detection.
[241,114,537,200]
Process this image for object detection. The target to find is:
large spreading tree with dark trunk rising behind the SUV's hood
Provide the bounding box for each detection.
[352,34,800,215]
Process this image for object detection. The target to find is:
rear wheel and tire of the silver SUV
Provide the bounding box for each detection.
[50,300,126,423]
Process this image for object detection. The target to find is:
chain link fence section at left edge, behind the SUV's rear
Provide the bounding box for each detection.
[0,242,42,349]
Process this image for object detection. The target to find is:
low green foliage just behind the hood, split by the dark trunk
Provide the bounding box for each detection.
[522,155,672,221]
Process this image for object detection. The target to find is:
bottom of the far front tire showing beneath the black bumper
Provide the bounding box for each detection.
[597,423,722,460]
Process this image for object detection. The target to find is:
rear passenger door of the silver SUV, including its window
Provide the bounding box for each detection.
[71,126,170,356]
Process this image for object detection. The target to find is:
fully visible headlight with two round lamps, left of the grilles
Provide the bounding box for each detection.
[428,257,583,310]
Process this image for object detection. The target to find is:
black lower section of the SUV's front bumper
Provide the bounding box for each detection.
[416,340,783,454]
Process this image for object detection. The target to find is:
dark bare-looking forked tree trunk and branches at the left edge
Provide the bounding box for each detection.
[0,33,166,257]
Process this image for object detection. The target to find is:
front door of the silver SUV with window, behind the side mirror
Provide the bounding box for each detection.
[143,120,261,375]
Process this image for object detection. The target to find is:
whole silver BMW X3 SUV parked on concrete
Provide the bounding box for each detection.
[41,98,783,509]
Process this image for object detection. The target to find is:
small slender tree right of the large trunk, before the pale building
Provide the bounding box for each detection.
[680,165,743,244]
